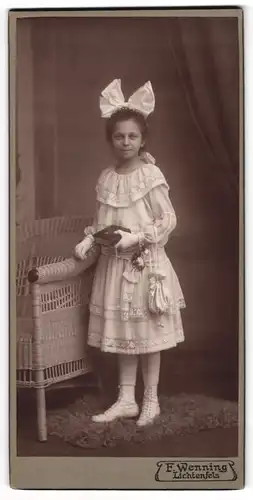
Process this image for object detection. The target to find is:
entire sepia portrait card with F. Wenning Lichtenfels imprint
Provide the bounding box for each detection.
[9,8,244,489]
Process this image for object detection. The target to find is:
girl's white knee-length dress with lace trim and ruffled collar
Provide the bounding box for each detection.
[86,163,185,354]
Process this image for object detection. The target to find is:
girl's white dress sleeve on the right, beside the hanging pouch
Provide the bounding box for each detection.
[140,184,177,243]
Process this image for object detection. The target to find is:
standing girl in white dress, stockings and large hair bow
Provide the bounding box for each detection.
[75,80,185,426]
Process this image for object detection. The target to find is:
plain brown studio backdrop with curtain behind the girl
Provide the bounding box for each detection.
[17,18,239,398]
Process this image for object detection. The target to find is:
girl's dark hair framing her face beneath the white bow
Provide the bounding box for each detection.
[105,108,148,150]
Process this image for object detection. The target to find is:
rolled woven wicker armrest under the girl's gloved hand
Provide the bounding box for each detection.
[28,246,100,284]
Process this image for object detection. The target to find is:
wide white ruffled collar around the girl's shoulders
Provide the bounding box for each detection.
[96,163,168,207]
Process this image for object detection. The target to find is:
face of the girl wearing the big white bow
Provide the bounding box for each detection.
[112,119,144,160]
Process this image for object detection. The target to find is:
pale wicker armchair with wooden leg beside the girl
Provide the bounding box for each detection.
[16,217,99,441]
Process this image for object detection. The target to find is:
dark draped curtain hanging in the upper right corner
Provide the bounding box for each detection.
[168,18,239,201]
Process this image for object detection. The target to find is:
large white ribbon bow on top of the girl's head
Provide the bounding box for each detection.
[100,79,155,118]
